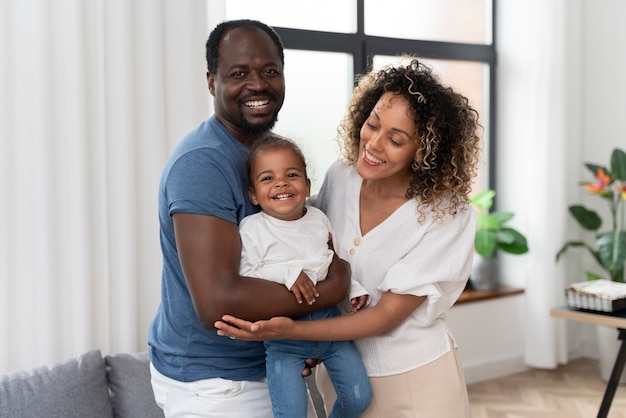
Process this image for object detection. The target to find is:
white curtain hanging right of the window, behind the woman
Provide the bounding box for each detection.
[497,0,582,368]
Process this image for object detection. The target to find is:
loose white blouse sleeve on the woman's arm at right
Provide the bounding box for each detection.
[379,210,475,325]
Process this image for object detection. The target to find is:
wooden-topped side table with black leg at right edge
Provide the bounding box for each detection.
[550,307,626,418]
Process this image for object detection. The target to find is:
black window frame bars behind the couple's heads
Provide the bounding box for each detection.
[274,0,497,190]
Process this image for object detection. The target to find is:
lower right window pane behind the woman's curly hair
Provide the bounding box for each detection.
[373,55,489,191]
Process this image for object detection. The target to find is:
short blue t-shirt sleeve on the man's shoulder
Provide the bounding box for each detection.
[165,149,238,223]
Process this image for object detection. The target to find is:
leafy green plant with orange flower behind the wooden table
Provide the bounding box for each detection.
[556,148,626,282]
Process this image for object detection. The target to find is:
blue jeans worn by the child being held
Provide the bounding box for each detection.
[265,308,372,418]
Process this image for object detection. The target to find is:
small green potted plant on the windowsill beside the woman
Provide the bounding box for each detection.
[470,189,528,290]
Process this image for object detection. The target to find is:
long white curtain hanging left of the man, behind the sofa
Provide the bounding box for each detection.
[0,0,208,373]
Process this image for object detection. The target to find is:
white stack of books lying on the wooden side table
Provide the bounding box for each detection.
[565,279,626,312]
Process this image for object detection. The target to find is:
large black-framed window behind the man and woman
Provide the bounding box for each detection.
[221,0,496,193]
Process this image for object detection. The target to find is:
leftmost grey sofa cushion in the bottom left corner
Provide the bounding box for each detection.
[0,350,113,418]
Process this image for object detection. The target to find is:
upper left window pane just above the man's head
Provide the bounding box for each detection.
[224,0,356,33]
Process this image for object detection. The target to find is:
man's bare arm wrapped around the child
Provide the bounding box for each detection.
[173,213,350,329]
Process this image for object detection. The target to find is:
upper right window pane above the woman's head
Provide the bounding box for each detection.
[365,0,492,45]
